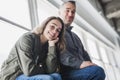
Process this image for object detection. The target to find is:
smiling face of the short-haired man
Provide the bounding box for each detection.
[59,2,76,25]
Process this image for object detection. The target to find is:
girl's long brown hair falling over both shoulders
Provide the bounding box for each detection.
[32,16,65,51]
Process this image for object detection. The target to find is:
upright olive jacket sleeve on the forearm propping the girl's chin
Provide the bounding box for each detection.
[46,46,58,73]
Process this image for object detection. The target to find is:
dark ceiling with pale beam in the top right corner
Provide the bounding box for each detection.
[93,0,120,34]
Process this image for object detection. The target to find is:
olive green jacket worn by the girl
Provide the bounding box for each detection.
[0,32,58,80]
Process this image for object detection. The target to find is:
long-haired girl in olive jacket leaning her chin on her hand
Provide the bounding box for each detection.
[0,16,65,80]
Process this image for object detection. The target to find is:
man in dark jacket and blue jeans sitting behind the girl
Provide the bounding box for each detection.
[59,1,105,80]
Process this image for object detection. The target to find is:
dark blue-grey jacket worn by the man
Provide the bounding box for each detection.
[60,33,90,69]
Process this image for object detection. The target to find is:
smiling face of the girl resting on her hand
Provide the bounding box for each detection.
[43,19,62,40]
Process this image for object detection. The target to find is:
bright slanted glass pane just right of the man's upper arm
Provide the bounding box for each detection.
[87,38,100,59]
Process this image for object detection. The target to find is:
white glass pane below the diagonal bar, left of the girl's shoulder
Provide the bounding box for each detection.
[0,20,27,67]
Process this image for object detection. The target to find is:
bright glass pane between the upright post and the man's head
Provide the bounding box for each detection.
[37,0,58,23]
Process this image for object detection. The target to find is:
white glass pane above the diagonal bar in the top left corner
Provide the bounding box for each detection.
[0,0,31,29]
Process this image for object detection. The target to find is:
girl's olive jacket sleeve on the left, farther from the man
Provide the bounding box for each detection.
[16,35,44,76]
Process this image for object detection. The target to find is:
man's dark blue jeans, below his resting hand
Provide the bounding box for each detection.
[62,66,105,80]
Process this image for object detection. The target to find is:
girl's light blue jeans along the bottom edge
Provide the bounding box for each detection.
[16,73,62,80]
